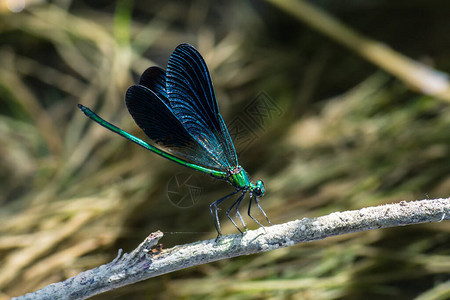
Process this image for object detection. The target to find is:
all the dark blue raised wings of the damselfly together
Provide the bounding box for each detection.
[126,44,238,171]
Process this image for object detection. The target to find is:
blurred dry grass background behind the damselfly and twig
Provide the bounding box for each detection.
[0,0,450,299]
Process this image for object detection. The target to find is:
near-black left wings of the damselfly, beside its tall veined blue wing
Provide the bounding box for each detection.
[126,67,230,169]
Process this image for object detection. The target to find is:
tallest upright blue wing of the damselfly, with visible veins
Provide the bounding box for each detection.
[166,44,238,168]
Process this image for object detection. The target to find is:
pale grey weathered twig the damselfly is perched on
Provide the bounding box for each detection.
[15,198,450,300]
